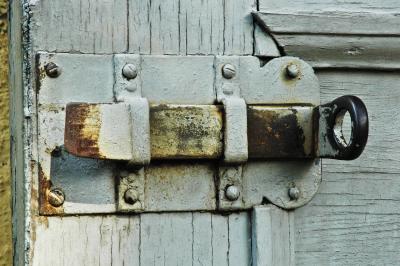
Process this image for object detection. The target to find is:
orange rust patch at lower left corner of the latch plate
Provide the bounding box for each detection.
[39,164,64,215]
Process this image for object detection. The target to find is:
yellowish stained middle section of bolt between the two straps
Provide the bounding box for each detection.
[150,105,223,159]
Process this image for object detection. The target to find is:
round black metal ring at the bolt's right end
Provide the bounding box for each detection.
[324,95,368,160]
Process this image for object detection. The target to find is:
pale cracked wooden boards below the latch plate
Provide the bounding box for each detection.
[33,212,251,266]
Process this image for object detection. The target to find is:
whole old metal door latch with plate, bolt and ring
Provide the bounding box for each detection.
[38,54,368,214]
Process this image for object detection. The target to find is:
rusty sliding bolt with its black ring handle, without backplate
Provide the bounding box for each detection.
[65,95,368,163]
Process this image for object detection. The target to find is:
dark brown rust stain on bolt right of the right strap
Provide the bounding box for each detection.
[247,107,308,158]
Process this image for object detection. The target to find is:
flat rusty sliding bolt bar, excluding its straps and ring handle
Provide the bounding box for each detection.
[64,103,315,160]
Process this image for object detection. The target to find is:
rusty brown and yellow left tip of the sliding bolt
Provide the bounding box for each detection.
[64,103,104,158]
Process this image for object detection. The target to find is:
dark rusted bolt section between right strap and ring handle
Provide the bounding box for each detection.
[247,106,315,158]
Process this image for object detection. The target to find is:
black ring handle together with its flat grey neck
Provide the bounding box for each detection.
[319,95,368,160]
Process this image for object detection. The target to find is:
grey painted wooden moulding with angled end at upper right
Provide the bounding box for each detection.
[256,0,400,69]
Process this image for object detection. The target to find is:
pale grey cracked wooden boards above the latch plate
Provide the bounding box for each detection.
[31,0,256,55]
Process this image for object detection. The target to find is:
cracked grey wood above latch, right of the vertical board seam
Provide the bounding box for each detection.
[128,0,256,55]
